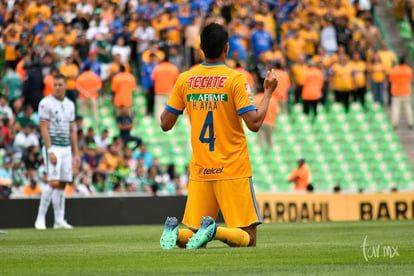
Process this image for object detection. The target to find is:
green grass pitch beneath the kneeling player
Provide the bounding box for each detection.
[0,220,414,276]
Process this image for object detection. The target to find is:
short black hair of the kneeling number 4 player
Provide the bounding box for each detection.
[200,23,229,59]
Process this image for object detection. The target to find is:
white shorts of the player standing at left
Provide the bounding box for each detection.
[43,146,73,183]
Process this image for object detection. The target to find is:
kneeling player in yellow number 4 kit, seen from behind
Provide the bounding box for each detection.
[160,23,277,249]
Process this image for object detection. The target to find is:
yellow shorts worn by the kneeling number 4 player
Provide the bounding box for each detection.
[182,177,262,230]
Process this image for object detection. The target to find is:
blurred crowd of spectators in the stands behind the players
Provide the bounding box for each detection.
[0,0,410,196]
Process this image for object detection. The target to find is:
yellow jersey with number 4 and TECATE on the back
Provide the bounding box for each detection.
[166,63,257,181]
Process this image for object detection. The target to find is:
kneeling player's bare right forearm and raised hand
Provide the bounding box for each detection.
[241,69,278,132]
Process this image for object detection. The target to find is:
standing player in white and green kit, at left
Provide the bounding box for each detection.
[35,74,80,230]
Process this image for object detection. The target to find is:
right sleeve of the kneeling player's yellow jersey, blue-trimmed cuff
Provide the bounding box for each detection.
[233,74,257,115]
